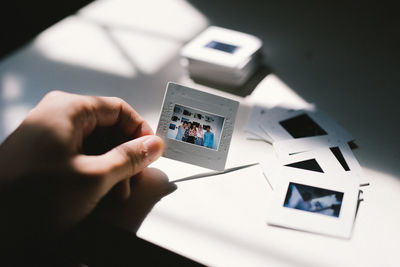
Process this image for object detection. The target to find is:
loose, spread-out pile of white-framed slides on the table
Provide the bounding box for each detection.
[245,106,365,238]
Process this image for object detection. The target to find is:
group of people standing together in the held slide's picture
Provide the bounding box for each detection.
[175,121,214,148]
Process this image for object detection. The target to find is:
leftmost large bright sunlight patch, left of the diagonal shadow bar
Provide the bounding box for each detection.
[34,17,136,77]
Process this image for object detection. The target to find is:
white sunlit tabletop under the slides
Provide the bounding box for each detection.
[0,0,400,266]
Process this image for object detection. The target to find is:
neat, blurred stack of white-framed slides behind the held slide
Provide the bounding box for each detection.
[181,26,262,87]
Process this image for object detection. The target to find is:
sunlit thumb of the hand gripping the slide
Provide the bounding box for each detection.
[77,135,164,194]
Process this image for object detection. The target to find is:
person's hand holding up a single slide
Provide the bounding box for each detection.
[0,92,164,250]
